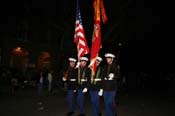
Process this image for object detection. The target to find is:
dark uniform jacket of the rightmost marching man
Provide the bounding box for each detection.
[103,62,119,91]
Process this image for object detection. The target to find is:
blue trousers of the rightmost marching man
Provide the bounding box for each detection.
[103,91,116,116]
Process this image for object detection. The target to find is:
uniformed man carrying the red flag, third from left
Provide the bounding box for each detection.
[89,57,103,116]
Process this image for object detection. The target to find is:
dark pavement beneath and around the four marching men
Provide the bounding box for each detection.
[0,89,175,116]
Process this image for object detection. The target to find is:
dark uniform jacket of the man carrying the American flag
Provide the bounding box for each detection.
[77,66,91,89]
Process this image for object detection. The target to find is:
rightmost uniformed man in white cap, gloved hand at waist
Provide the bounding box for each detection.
[103,53,119,116]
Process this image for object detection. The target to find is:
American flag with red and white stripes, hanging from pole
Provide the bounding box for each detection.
[74,0,89,58]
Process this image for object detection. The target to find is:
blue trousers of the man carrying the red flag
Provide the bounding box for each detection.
[90,91,100,116]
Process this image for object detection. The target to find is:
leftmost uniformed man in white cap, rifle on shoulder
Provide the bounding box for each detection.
[63,58,77,116]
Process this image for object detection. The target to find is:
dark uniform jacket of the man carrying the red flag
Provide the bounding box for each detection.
[89,66,103,91]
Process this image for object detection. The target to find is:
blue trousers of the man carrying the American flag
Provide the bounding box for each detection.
[77,90,84,114]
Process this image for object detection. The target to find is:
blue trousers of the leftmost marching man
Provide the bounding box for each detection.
[67,90,74,112]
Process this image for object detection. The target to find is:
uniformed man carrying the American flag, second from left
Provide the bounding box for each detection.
[77,57,91,116]
